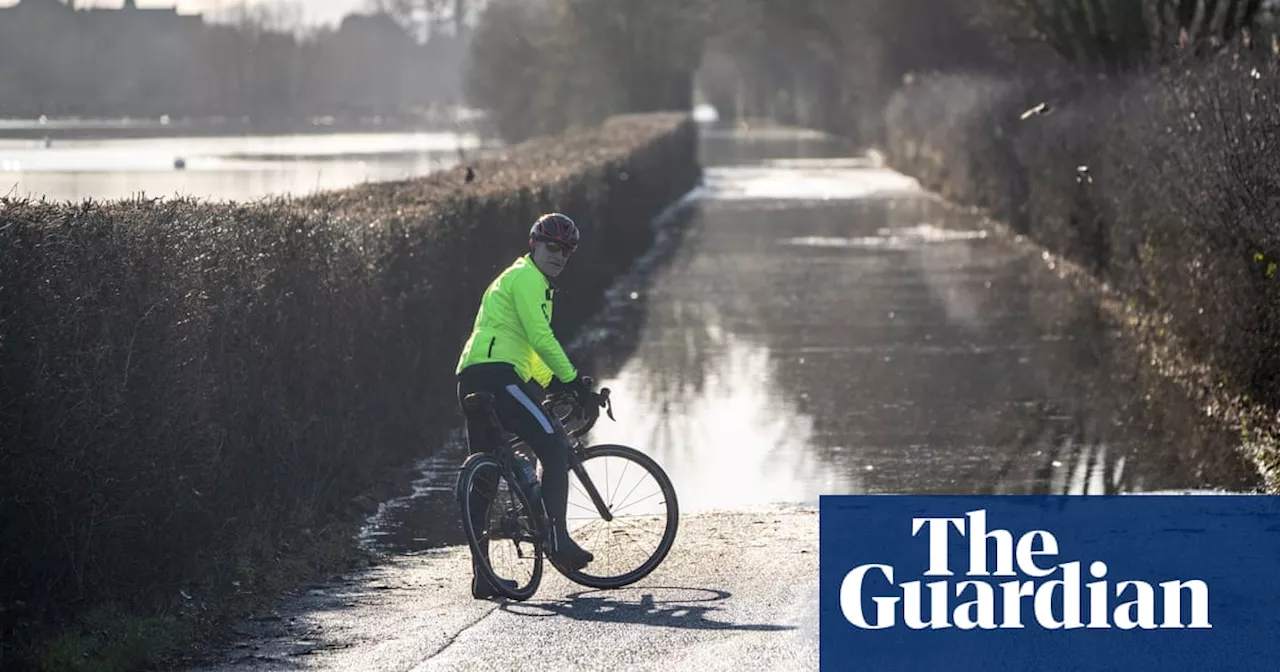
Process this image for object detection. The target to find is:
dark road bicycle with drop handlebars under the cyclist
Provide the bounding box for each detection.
[454,379,680,602]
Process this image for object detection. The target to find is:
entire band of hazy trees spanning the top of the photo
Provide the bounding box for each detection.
[0,0,1270,140]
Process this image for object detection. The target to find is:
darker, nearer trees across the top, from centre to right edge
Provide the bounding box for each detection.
[463,0,1271,138]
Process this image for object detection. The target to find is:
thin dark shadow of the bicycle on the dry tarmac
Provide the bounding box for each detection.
[499,586,796,631]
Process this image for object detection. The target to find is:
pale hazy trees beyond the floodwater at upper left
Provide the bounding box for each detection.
[0,1,470,122]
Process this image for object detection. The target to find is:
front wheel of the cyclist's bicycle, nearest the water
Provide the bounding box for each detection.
[552,444,680,589]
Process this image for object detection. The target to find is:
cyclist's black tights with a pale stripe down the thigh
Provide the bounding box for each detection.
[458,362,571,542]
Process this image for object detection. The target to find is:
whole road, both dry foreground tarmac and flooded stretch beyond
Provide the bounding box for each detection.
[197,127,1253,669]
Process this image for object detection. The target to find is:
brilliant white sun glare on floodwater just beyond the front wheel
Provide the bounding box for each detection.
[591,311,860,511]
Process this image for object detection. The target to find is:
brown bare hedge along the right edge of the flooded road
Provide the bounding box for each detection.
[884,54,1280,485]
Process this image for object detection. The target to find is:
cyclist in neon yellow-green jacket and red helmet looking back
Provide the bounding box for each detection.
[457,212,595,599]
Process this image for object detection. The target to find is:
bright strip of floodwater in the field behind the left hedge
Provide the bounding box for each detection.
[0,132,488,201]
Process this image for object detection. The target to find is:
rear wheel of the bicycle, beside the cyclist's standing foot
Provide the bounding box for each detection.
[457,453,543,600]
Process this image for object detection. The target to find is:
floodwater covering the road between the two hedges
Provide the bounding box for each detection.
[367,125,1254,550]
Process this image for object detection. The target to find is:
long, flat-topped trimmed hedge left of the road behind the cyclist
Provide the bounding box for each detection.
[0,114,699,632]
